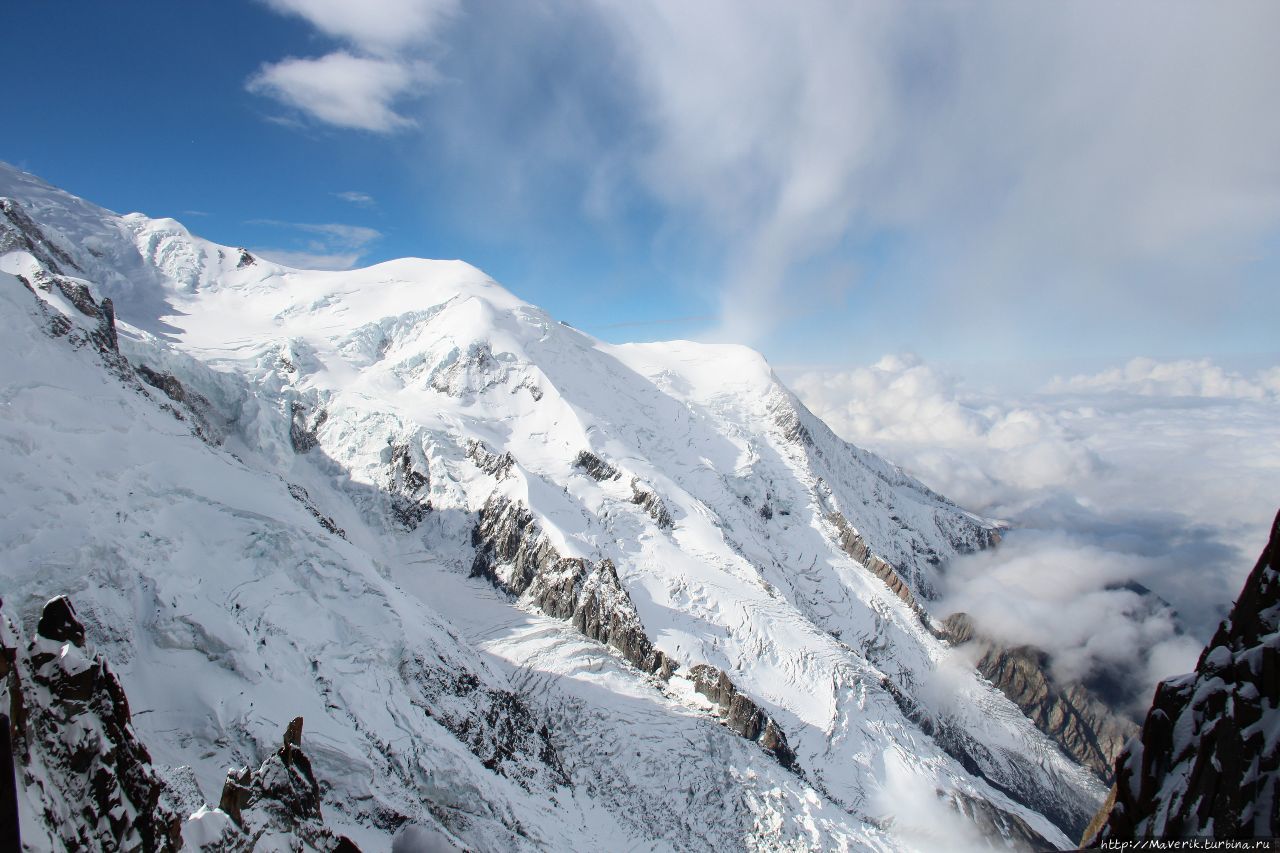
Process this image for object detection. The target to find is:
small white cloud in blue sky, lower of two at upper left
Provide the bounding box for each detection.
[240,51,419,133]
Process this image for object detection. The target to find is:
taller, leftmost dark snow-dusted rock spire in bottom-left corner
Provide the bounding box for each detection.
[0,597,182,850]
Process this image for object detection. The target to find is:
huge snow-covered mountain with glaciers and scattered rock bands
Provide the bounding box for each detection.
[0,165,1105,850]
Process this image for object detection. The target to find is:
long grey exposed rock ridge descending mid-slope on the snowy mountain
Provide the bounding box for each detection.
[471,494,795,768]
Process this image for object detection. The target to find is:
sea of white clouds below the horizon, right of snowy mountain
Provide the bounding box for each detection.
[791,357,1280,702]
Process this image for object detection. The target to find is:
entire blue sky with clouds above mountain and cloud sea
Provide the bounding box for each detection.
[0,0,1280,375]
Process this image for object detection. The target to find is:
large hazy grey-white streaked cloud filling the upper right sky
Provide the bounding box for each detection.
[588,0,1280,336]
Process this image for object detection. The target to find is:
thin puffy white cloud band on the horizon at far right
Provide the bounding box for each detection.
[1048,359,1280,400]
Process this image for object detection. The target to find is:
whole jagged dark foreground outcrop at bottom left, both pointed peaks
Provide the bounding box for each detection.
[0,596,358,853]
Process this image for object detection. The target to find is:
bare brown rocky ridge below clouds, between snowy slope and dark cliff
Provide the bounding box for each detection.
[942,613,1138,785]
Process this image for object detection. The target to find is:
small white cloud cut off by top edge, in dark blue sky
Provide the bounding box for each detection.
[266,0,458,53]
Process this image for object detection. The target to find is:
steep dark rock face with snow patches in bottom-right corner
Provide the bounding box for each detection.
[1088,515,1280,845]
